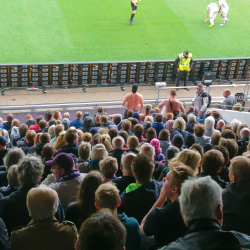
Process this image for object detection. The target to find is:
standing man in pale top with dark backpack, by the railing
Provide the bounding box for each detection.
[192,83,209,117]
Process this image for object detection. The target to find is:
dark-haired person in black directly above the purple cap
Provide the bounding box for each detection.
[55,128,79,157]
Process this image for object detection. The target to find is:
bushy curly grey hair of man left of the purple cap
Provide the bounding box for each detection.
[18,155,44,185]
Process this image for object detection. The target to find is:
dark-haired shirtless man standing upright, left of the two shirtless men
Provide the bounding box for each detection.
[122,83,143,119]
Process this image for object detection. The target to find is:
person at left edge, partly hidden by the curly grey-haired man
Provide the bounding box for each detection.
[0,165,20,196]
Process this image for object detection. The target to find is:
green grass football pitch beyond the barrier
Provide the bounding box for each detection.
[0,0,250,64]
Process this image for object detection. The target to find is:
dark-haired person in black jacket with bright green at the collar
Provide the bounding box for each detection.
[118,154,162,223]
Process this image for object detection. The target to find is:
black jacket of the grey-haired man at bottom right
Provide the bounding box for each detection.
[161,219,250,250]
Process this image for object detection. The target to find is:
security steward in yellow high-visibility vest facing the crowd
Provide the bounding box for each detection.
[175,51,193,91]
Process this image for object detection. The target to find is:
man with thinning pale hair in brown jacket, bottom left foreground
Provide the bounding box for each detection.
[10,186,77,250]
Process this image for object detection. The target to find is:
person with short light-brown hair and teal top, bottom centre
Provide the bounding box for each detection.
[95,183,141,250]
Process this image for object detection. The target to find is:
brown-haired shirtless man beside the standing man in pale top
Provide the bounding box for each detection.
[158,89,185,118]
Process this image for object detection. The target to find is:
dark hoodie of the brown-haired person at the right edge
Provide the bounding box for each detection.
[222,178,250,235]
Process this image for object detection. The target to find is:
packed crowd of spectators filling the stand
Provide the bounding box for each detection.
[0,83,250,250]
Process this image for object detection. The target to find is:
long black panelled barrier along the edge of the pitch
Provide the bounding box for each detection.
[0,58,250,88]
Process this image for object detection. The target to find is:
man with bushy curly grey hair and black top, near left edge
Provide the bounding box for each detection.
[0,154,63,237]
